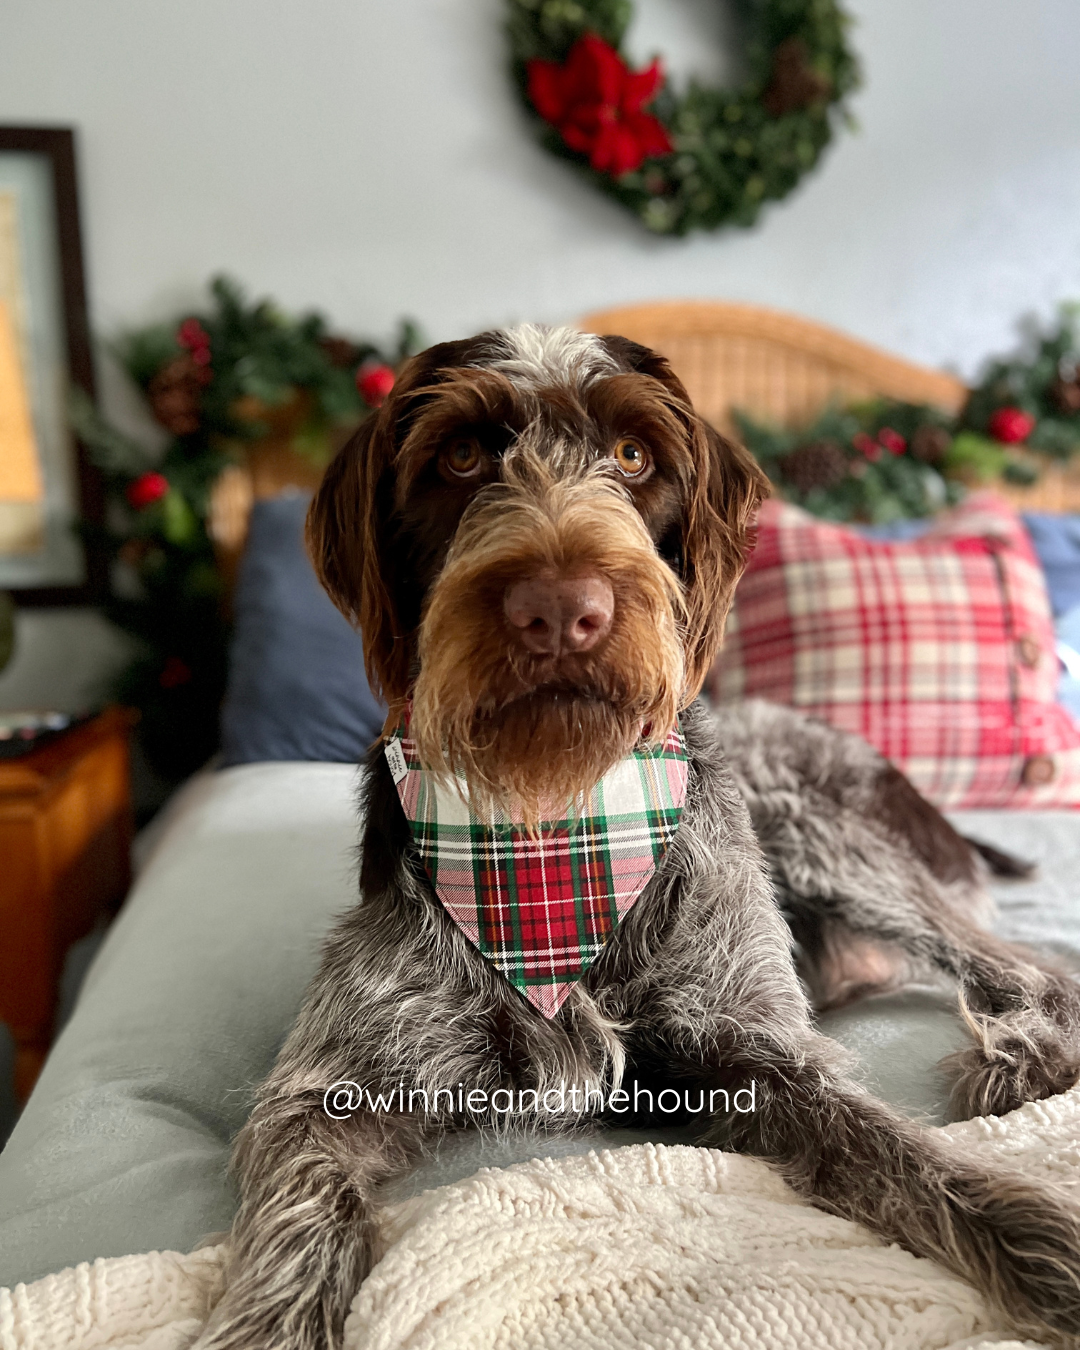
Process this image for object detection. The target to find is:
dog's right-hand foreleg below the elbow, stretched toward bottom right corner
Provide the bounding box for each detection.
[709,1037,1080,1346]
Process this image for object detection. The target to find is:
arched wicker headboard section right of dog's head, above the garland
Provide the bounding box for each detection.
[579,300,968,432]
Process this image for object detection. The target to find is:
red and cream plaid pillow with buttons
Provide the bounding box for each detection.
[709,491,1080,809]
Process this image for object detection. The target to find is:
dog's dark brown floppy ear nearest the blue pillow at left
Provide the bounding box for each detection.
[306,413,409,716]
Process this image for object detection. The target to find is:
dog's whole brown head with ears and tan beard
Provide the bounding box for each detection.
[308,325,767,818]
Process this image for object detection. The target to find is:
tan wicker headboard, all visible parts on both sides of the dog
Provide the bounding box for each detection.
[209,300,1080,581]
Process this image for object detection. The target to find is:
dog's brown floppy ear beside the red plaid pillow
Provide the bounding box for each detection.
[682,419,771,703]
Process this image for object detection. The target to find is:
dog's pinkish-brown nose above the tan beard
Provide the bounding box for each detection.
[502,574,616,656]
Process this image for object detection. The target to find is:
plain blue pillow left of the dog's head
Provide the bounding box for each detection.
[221,491,385,768]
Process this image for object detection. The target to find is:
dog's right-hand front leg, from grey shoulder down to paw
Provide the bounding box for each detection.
[624,770,1080,1345]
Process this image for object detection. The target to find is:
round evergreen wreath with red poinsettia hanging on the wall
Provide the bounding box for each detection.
[509,0,859,235]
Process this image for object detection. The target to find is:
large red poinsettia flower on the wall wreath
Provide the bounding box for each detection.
[527,32,674,178]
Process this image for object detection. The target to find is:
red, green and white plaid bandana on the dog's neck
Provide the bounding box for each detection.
[386,722,687,1018]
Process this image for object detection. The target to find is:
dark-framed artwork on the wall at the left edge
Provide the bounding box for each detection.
[0,127,103,605]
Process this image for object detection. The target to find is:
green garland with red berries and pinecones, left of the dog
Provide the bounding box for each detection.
[72,278,420,779]
